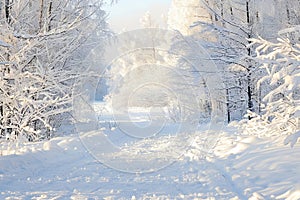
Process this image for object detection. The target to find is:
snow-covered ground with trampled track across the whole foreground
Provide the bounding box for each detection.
[0,109,300,200]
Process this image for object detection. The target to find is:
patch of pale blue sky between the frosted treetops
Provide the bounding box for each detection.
[105,0,171,32]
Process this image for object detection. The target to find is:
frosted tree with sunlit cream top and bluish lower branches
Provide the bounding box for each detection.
[168,0,230,122]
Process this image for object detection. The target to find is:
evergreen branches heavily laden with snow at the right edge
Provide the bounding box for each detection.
[240,35,300,144]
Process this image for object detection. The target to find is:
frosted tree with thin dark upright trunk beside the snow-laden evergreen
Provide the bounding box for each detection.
[188,0,300,121]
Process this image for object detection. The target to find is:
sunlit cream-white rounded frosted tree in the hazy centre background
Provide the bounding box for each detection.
[105,29,180,117]
